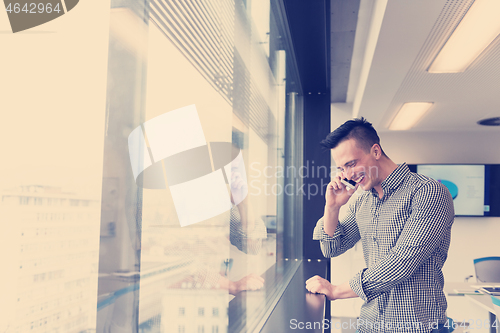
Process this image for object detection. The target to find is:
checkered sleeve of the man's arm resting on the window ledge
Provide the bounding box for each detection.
[349,182,455,302]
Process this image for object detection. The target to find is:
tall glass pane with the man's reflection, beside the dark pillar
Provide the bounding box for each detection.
[97,0,302,332]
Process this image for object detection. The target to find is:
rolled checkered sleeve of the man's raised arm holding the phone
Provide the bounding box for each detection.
[313,200,361,258]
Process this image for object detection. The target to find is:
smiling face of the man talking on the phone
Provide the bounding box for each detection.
[332,139,379,191]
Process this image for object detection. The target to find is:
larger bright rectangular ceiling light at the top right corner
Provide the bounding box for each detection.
[428,0,500,73]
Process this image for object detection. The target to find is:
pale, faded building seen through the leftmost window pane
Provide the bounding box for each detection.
[0,185,99,332]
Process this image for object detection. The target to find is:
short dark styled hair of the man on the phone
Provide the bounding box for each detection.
[321,117,387,157]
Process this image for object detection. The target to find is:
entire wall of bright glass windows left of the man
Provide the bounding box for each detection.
[0,0,302,333]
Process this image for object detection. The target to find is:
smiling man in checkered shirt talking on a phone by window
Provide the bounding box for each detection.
[306,118,454,332]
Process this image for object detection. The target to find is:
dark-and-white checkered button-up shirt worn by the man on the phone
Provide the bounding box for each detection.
[313,164,454,332]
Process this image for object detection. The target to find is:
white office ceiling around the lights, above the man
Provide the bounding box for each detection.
[348,0,500,132]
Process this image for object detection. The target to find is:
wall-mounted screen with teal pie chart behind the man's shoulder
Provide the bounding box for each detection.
[409,164,500,216]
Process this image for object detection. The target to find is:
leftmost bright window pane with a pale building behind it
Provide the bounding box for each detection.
[0,0,110,333]
